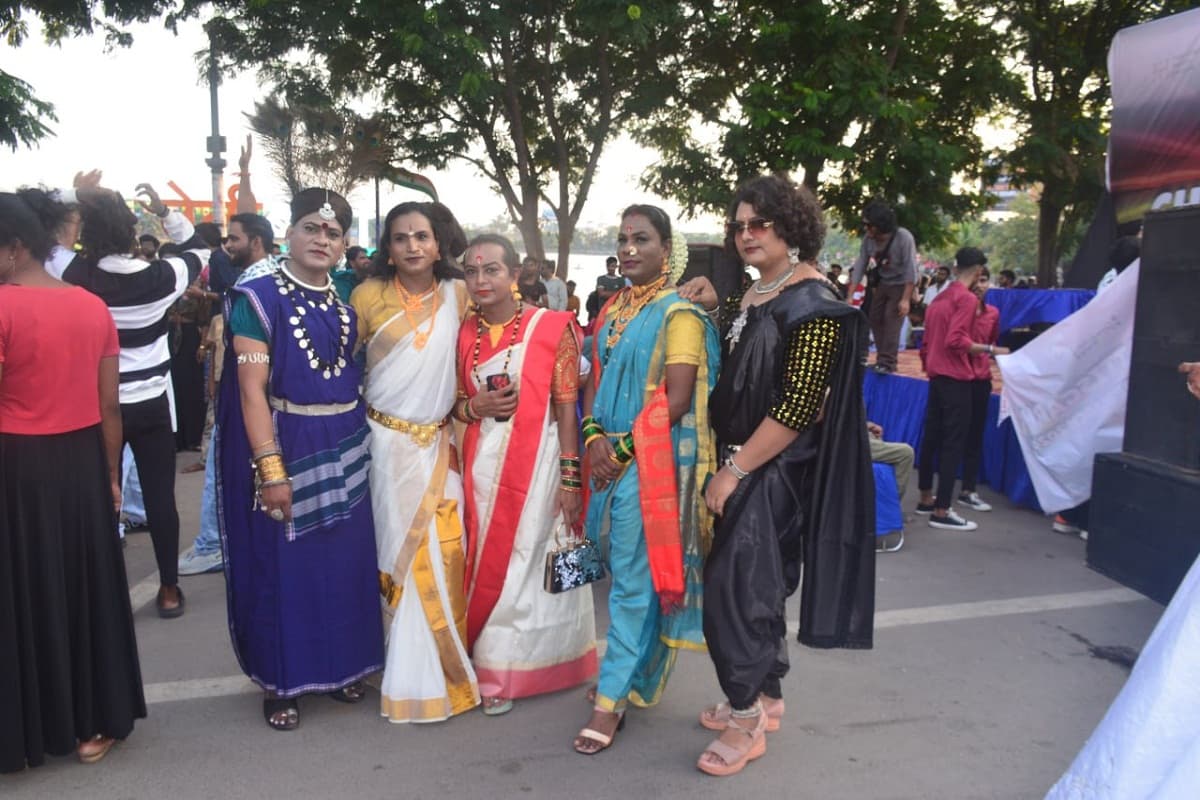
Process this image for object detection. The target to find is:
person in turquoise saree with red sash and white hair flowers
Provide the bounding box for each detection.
[575,205,720,754]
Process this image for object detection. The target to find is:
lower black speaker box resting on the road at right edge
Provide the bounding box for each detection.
[1087,453,1200,606]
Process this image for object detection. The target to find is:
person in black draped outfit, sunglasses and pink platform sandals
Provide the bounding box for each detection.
[679,176,875,775]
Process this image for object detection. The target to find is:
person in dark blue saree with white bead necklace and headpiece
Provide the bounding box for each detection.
[216,188,384,730]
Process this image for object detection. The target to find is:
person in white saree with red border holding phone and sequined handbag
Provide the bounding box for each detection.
[455,234,596,715]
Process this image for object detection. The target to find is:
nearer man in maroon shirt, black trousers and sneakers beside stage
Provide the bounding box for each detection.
[917,247,997,530]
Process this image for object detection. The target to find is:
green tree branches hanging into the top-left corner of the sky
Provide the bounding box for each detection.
[0,0,178,150]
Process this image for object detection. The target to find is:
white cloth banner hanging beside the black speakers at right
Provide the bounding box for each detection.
[996,261,1140,513]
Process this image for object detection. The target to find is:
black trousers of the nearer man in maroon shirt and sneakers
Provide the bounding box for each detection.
[917,375,971,509]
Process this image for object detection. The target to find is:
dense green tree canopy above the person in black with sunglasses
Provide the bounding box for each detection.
[638,0,1015,242]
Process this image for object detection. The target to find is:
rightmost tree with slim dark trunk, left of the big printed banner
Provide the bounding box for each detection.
[967,0,1194,287]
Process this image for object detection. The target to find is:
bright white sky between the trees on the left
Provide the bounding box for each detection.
[0,13,720,244]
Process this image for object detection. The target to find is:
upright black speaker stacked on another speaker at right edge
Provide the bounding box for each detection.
[1123,206,1200,472]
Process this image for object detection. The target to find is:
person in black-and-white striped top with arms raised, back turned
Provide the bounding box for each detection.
[62,174,200,618]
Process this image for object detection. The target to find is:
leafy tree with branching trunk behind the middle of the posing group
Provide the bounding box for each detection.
[202,0,684,275]
